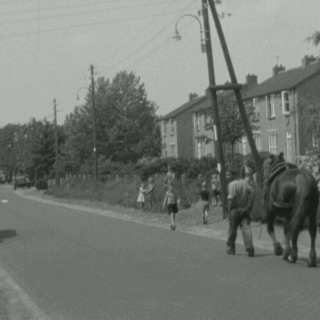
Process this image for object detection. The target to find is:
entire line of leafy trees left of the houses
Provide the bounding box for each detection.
[0,71,161,180]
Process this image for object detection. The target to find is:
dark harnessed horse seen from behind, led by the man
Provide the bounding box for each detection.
[264,157,319,267]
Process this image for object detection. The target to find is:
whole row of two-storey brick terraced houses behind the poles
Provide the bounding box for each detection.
[161,56,320,162]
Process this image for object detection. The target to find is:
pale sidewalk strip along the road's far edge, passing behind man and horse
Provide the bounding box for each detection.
[15,189,320,257]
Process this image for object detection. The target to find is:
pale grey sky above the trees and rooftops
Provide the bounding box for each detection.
[0,0,320,127]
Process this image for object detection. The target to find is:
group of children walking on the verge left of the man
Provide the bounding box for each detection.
[137,168,220,230]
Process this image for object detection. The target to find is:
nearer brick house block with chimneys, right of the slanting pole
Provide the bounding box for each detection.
[242,56,320,162]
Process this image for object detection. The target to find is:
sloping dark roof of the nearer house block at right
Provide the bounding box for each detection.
[245,61,320,99]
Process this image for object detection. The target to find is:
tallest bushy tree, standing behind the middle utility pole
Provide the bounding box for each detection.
[64,71,161,168]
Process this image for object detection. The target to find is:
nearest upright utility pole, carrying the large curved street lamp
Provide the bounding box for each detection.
[202,0,227,218]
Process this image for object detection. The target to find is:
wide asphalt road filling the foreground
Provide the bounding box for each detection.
[0,187,320,320]
